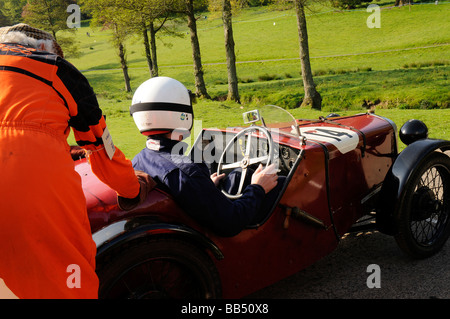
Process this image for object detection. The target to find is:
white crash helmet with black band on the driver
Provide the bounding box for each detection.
[130,76,194,136]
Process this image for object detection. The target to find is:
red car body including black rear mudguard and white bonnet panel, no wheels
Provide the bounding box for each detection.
[76,113,450,298]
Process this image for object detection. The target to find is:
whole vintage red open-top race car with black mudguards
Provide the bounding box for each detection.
[76,106,450,298]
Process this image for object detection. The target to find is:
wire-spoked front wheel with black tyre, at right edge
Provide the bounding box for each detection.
[395,152,450,258]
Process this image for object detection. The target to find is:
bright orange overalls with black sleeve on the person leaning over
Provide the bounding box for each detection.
[0,43,140,298]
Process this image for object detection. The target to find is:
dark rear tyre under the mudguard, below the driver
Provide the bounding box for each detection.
[97,238,221,299]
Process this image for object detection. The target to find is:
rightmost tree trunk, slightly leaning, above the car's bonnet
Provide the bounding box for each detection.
[294,0,322,110]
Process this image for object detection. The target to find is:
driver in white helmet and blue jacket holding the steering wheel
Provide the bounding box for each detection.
[130,77,282,236]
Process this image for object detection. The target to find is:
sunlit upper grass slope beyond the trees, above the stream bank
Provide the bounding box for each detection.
[68,2,450,71]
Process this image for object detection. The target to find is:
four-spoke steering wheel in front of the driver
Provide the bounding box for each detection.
[217,126,274,199]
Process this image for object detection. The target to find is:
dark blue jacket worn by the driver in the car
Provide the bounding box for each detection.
[132,138,266,236]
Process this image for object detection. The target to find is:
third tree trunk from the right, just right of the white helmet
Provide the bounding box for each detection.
[186,0,211,99]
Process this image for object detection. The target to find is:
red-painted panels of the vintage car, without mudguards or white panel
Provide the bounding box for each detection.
[76,114,396,298]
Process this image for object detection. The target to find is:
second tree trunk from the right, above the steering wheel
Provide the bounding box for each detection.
[222,0,240,103]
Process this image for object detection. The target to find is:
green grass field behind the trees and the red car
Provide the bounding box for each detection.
[68,2,450,157]
